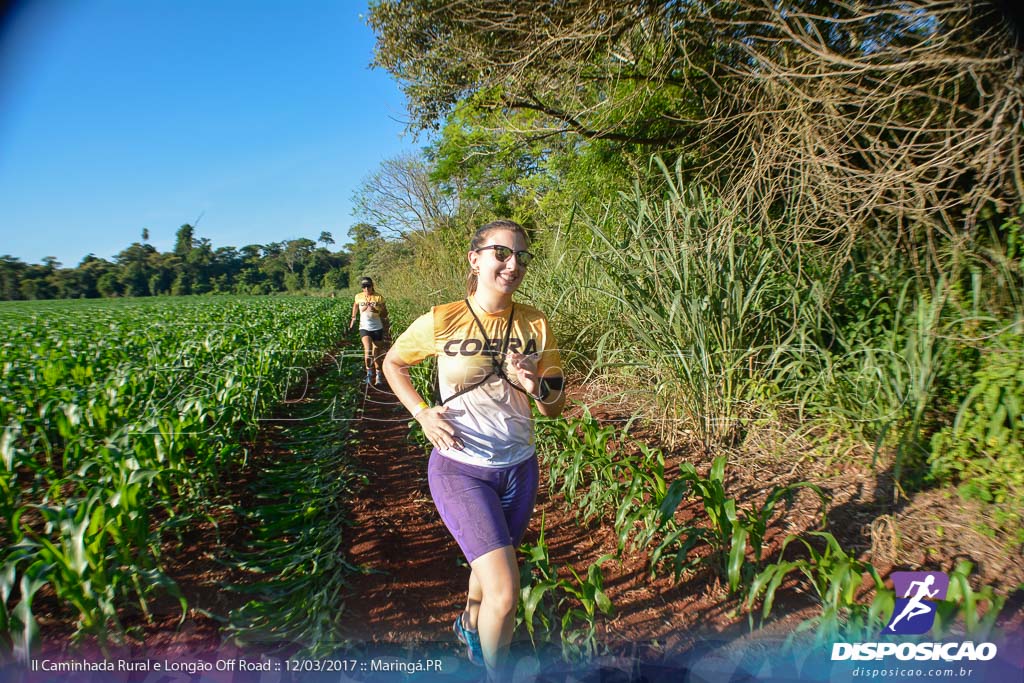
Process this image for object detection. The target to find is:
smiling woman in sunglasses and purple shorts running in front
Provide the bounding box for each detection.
[384,220,565,678]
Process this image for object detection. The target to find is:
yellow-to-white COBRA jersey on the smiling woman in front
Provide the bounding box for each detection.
[393,298,562,467]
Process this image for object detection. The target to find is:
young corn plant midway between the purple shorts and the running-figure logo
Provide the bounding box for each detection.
[650,456,826,593]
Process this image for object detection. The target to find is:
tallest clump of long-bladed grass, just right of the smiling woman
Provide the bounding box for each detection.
[589,159,813,450]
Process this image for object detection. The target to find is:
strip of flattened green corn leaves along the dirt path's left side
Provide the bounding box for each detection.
[227,366,368,656]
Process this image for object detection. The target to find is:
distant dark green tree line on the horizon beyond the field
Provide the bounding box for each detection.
[0,222,382,301]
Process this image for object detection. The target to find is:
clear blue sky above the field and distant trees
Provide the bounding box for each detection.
[0,0,423,266]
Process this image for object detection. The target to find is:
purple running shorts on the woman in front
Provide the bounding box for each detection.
[427,450,539,563]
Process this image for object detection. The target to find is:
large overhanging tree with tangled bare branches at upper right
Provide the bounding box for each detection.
[370,0,1024,272]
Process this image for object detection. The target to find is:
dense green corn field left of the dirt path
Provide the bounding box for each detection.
[0,297,345,658]
